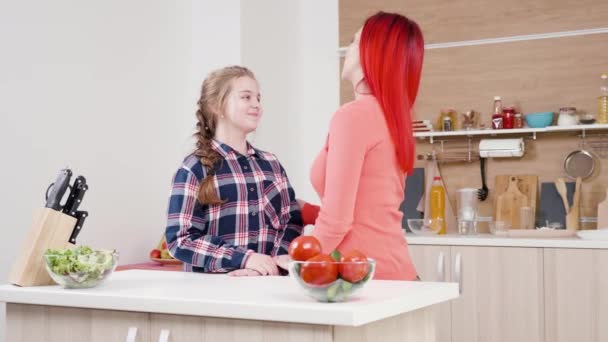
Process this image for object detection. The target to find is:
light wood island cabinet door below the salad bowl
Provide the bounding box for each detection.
[6,304,150,342]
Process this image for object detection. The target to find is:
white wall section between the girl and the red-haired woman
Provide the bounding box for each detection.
[241,0,339,203]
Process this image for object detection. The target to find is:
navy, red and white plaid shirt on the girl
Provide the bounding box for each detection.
[165,140,302,272]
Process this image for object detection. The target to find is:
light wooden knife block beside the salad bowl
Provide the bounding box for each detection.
[8,208,76,286]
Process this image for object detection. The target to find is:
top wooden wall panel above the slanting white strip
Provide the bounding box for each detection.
[339,0,608,46]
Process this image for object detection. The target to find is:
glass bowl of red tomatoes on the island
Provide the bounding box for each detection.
[289,236,376,302]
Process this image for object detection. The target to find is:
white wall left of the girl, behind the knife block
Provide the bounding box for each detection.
[0,0,240,280]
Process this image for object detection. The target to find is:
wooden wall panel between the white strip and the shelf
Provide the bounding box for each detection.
[416,33,608,124]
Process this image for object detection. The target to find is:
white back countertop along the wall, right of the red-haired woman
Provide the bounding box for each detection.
[405,233,608,249]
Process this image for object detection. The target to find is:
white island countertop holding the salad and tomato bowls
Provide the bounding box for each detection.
[0,270,458,326]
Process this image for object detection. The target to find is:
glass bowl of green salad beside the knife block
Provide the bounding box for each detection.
[43,246,118,289]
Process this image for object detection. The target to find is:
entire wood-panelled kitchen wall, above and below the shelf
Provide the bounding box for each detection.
[340,0,608,230]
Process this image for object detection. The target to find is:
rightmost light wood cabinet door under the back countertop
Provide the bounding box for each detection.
[544,248,608,342]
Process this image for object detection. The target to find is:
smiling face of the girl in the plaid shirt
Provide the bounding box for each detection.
[225,76,262,134]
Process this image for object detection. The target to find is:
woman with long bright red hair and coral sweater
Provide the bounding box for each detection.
[303,12,424,280]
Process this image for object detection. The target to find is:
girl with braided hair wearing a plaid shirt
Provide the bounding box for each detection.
[165,66,302,275]
